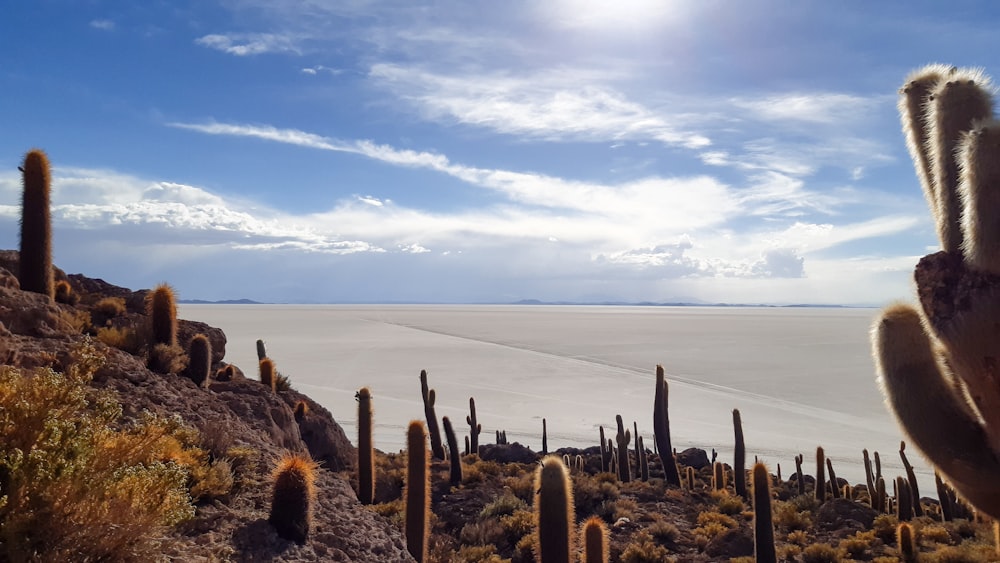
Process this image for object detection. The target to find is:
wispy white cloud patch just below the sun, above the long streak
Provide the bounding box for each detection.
[370,64,711,148]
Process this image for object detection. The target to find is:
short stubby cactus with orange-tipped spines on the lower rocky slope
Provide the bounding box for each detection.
[267,454,317,544]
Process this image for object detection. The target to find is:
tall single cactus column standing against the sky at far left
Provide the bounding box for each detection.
[18,149,54,298]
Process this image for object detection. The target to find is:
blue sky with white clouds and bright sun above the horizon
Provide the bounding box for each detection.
[0,0,1000,304]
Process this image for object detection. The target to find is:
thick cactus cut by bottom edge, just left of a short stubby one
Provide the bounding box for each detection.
[534,455,576,563]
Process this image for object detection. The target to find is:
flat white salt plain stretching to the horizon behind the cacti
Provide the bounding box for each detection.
[180,305,936,496]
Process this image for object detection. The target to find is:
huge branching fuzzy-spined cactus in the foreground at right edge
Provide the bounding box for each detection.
[872,65,1000,518]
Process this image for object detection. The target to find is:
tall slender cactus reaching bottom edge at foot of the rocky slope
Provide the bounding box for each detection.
[405,420,431,563]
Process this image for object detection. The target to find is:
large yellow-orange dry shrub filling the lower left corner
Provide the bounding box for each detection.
[0,345,194,561]
